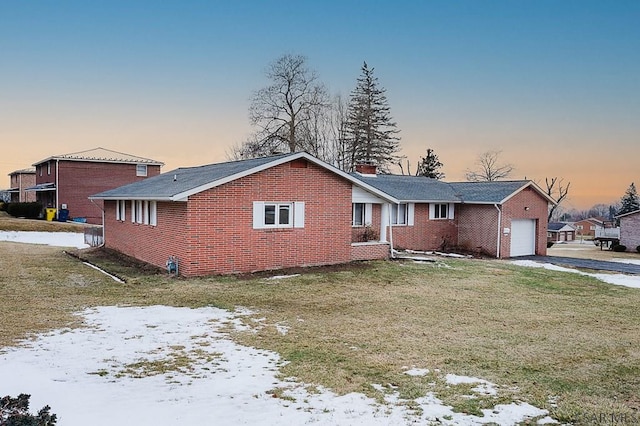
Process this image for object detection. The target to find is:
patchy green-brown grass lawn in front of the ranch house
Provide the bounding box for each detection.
[0,221,640,424]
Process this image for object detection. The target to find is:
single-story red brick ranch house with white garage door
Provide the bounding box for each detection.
[90,152,550,276]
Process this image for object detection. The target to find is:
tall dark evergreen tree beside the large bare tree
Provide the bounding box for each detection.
[345,62,400,171]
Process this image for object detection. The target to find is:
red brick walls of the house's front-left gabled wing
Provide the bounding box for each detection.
[105,162,352,276]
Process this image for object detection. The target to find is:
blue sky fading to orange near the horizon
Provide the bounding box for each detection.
[0,0,640,209]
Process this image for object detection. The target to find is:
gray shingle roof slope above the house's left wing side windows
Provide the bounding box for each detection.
[90,154,300,200]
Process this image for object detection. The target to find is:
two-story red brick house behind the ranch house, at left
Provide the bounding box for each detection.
[28,148,163,224]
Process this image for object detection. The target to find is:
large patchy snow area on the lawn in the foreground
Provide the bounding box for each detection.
[0,306,547,426]
